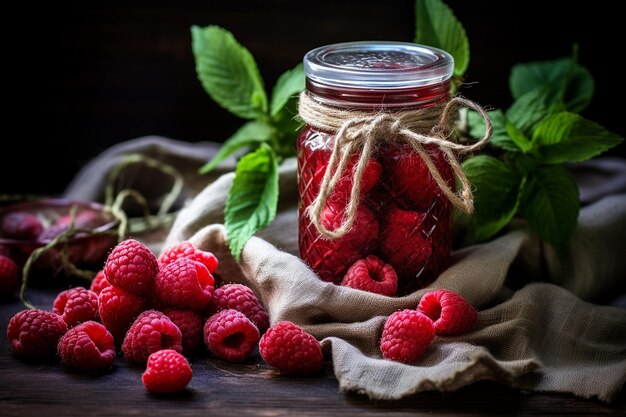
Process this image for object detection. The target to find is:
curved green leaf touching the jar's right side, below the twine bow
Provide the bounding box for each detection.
[462,155,522,240]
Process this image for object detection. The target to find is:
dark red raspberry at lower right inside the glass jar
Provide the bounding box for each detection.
[379,207,433,293]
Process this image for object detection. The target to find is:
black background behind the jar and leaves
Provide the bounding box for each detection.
[0,0,626,194]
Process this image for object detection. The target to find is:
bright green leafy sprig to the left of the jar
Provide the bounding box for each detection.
[191,26,305,259]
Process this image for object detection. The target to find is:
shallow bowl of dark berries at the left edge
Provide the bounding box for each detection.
[0,198,120,274]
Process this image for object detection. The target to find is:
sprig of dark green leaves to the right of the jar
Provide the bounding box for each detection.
[463,57,623,249]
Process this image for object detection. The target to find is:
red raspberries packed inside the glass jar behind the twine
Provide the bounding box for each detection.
[300,145,455,296]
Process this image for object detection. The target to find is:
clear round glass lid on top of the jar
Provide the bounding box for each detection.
[303,41,454,89]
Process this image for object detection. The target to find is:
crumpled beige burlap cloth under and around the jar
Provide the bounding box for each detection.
[66,137,626,401]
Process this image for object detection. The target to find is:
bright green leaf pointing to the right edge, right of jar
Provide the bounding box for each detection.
[532,112,623,164]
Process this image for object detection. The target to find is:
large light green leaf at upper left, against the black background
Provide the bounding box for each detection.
[191,26,267,119]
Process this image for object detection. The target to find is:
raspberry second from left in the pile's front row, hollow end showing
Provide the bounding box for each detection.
[58,321,116,371]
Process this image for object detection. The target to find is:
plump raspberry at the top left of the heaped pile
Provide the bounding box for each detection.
[104,239,159,294]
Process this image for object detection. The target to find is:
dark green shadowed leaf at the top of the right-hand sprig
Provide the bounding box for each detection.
[509,58,594,112]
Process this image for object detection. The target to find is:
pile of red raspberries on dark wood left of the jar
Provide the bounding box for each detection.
[6,239,323,393]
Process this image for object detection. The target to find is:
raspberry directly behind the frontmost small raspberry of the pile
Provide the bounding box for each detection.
[122,310,183,363]
